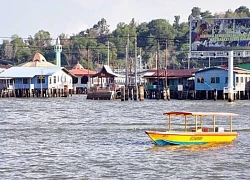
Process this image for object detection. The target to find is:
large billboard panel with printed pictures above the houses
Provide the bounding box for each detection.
[190,18,250,51]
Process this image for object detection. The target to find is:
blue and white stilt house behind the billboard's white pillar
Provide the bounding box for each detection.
[195,66,250,99]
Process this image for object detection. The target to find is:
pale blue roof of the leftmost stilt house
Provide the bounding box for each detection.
[0,67,62,78]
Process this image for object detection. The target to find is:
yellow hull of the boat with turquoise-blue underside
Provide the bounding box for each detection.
[146,131,238,146]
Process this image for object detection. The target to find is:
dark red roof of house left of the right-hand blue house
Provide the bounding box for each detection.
[144,69,199,78]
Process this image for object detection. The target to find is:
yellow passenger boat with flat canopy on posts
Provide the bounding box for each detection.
[146,112,238,146]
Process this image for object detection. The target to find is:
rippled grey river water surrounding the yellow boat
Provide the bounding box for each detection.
[0,95,250,180]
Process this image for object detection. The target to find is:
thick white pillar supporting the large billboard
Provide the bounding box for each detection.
[228,51,234,102]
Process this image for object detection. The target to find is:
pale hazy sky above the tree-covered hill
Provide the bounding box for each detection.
[0,0,250,39]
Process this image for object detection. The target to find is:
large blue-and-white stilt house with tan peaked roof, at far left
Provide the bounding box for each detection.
[0,53,74,97]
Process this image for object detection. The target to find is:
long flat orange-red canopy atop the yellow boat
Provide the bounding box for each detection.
[163,111,238,116]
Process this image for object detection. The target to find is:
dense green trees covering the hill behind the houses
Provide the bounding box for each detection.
[0,6,250,69]
